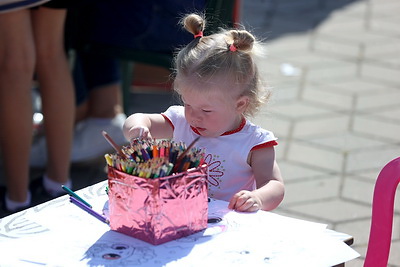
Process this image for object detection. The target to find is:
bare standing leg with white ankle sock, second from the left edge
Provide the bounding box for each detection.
[32,7,75,196]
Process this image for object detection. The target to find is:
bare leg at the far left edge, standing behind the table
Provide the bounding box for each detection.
[0,9,35,214]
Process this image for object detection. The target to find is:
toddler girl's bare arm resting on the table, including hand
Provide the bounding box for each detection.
[228,147,285,212]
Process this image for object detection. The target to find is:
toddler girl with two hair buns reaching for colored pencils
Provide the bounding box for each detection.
[123,14,284,212]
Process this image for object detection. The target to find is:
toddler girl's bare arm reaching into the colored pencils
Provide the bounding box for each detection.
[122,113,173,141]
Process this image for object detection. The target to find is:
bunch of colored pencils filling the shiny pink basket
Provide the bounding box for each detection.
[104,139,204,178]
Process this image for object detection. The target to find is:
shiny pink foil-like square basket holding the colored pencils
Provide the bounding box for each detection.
[108,165,208,245]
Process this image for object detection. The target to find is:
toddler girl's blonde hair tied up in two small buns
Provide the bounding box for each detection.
[174,14,270,117]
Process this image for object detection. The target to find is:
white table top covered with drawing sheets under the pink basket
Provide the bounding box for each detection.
[0,181,359,267]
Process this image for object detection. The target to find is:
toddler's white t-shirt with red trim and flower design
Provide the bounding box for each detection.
[162,106,277,201]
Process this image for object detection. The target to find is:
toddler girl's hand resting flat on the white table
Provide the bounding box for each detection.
[228,190,262,212]
